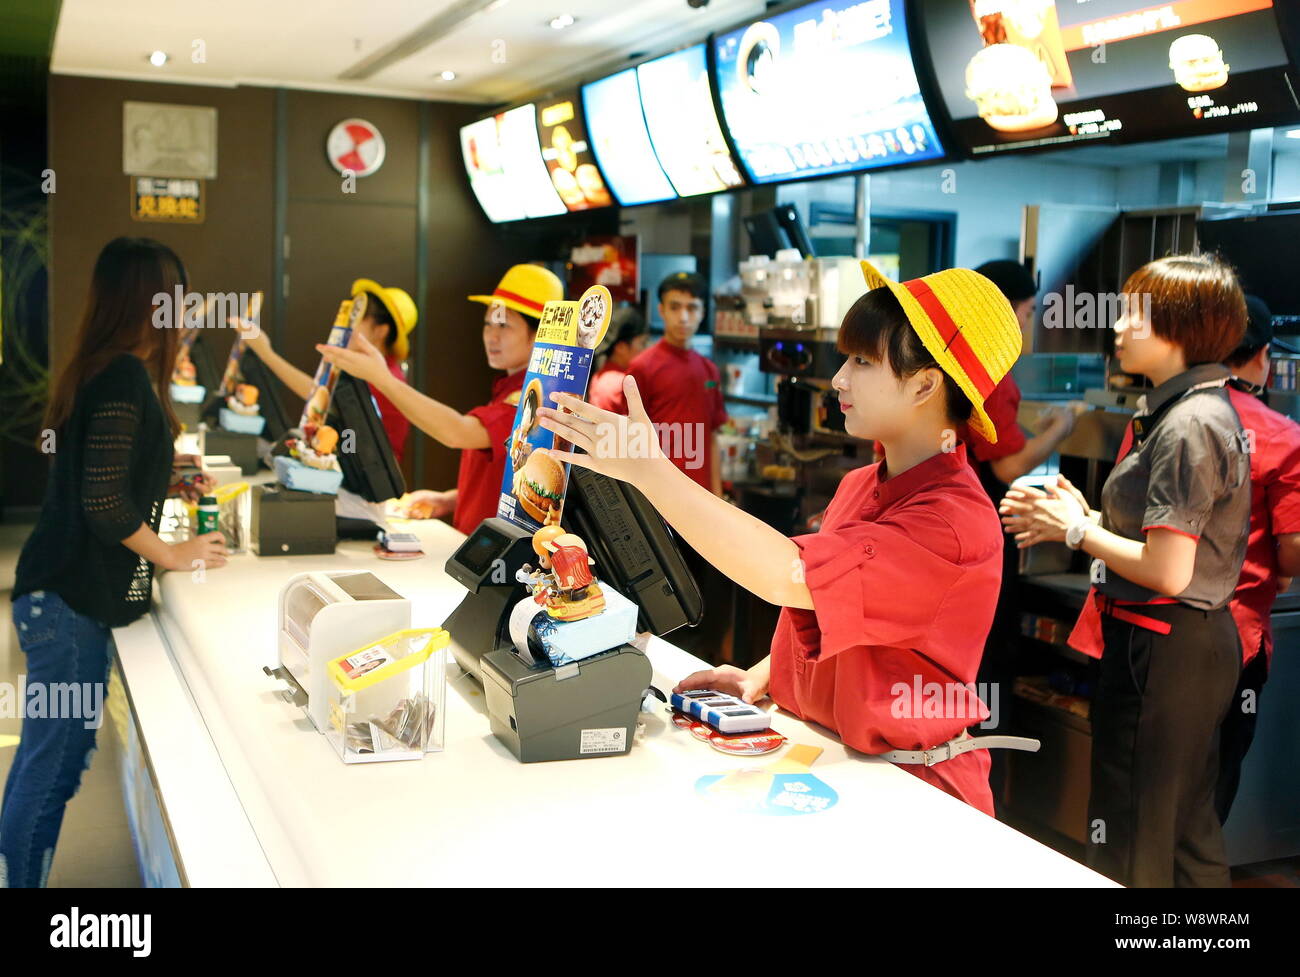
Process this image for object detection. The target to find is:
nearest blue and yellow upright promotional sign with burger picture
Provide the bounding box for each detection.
[497,285,614,530]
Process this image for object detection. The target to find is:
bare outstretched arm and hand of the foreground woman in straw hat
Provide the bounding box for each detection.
[537,377,813,608]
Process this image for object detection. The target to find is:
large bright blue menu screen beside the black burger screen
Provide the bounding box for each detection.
[714,0,952,183]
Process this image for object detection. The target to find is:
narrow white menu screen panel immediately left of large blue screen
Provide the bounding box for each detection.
[637,44,745,196]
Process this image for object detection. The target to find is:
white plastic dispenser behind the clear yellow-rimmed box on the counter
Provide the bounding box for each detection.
[263,570,411,733]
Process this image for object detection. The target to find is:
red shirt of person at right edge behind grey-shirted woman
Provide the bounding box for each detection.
[1227,387,1300,663]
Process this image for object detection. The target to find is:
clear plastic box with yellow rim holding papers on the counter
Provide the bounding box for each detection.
[324,628,447,763]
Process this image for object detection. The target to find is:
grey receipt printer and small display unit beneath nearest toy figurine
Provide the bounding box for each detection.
[443,518,653,763]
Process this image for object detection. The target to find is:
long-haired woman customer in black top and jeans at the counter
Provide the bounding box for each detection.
[0,238,226,887]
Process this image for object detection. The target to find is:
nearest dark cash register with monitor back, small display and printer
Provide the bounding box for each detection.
[443,466,703,763]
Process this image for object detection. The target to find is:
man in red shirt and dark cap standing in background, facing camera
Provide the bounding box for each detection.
[628,272,727,495]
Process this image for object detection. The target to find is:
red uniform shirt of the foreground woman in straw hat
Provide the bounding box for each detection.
[770,444,1002,816]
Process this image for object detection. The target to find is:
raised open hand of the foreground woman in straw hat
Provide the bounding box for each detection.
[537,377,664,485]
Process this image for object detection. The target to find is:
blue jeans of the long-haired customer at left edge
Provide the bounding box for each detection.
[0,590,113,889]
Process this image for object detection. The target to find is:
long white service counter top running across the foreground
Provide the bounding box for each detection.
[106,522,1110,886]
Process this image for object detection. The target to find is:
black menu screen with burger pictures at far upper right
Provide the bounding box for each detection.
[919,0,1300,155]
